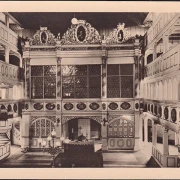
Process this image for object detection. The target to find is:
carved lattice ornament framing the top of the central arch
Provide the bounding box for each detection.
[62,116,102,124]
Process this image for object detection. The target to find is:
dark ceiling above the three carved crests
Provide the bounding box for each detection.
[10,12,148,35]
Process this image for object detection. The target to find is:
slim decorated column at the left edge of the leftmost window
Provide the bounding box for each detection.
[25,58,31,98]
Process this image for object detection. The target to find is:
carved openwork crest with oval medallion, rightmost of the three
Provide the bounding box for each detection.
[106,23,130,44]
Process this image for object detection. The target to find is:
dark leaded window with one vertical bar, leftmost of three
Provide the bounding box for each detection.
[31,66,56,99]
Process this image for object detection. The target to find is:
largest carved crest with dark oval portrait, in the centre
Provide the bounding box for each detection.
[61,20,101,44]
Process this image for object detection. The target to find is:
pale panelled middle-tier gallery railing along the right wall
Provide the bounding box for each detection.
[145,44,180,77]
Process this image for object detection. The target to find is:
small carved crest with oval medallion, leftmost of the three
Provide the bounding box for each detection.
[30,27,56,45]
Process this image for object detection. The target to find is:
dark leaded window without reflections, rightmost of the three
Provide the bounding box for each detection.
[107,64,133,98]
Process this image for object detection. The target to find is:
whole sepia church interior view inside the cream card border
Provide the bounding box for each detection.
[0,12,180,168]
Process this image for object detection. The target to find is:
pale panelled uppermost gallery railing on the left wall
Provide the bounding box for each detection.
[0,22,18,50]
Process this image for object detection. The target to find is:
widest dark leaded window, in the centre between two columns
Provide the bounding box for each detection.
[62,65,101,98]
